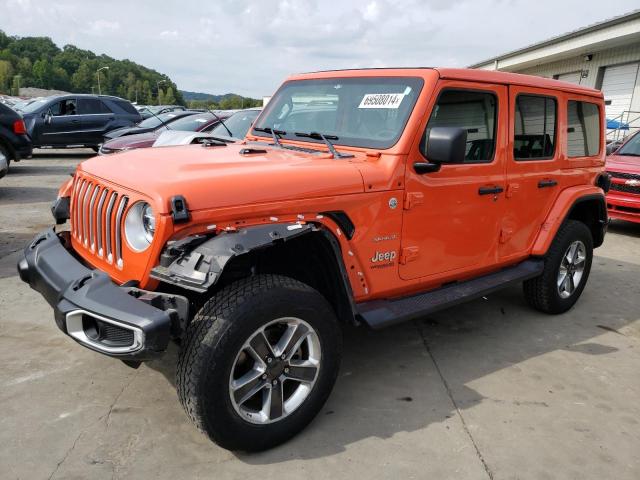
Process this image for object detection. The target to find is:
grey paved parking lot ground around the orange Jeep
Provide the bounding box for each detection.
[0,150,640,480]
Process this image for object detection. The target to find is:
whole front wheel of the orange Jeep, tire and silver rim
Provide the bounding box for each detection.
[177,275,342,451]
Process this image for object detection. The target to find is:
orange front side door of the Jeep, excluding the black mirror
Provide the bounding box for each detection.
[399,81,508,281]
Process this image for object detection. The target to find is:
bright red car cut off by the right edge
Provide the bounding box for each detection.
[607,132,640,223]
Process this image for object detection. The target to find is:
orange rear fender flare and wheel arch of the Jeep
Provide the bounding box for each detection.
[531,186,608,256]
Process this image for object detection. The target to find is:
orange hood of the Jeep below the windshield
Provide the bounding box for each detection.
[78,143,364,214]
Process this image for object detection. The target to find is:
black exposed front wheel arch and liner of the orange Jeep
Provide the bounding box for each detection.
[151,223,356,322]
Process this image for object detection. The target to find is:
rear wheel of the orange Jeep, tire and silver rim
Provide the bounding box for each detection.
[524,220,593,314]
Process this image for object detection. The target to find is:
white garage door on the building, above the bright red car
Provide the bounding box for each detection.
[601,63,640,121]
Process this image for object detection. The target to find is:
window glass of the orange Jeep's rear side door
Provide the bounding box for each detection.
[513,95,557,160]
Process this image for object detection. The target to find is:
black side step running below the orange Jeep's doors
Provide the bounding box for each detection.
[357,259,544,329]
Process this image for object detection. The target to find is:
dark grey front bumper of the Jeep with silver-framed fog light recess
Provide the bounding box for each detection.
[18,229,177,361]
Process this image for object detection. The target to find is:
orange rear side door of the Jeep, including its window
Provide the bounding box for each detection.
[500,85,561,260]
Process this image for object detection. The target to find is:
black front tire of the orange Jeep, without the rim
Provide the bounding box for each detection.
[176,275,342,451]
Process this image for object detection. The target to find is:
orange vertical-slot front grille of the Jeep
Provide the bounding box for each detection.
[71,177,129,268]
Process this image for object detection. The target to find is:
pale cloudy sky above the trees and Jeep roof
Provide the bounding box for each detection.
[0,0,638,97]
